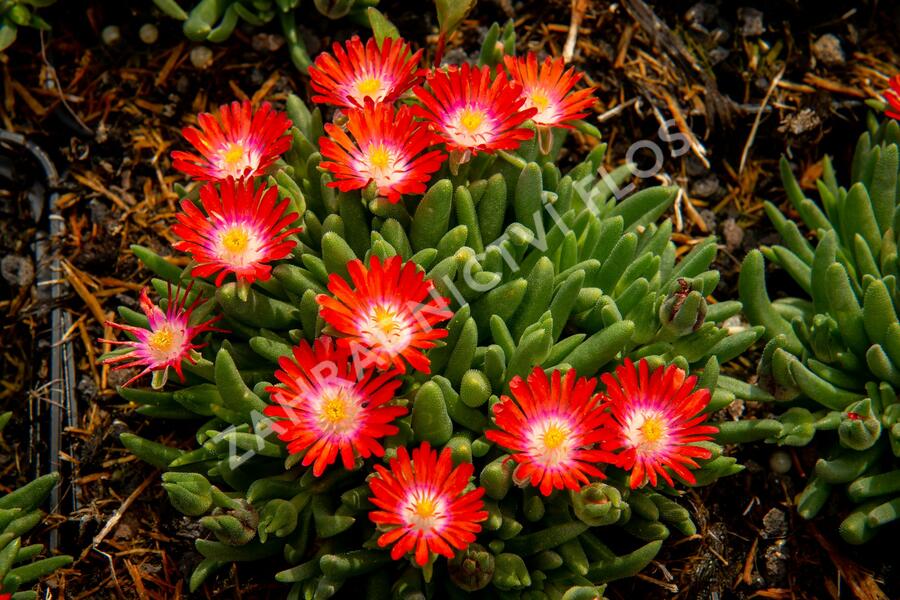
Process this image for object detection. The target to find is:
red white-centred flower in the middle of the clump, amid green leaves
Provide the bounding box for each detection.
[316,256,453,373]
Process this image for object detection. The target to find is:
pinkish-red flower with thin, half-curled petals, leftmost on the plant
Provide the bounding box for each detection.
[100,286,225,388]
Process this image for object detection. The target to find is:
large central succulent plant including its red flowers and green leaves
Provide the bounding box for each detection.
[106,27,770,599]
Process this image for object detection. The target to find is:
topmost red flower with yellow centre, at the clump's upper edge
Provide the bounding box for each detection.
[309,36,422,108]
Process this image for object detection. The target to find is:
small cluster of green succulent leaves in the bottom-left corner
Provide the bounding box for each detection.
[0,412,72,600]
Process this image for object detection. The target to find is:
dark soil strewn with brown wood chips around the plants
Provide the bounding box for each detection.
[0,0,900,599]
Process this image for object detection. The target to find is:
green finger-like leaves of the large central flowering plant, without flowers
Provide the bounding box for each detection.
[110,51,766,598]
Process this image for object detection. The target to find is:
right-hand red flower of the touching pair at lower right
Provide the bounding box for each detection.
[601,359,718,488]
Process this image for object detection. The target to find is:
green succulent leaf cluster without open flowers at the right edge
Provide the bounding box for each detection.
[740,117,900,544]
